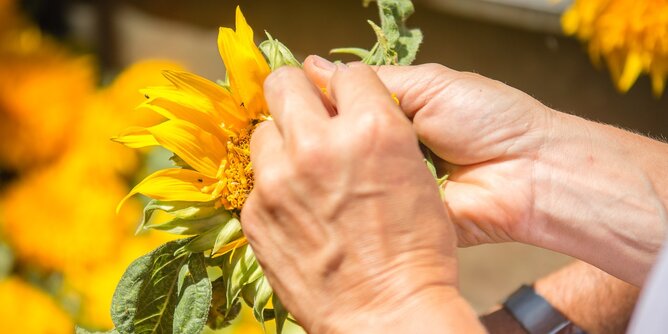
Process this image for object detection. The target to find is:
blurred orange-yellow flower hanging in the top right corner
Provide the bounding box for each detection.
[562,0,668,96]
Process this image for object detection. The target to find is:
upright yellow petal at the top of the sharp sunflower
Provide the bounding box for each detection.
[218,7,270,118]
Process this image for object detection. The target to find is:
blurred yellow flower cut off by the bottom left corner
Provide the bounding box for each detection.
[0,277,74,334]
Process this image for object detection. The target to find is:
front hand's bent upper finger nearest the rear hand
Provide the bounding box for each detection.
[328,63,403,117]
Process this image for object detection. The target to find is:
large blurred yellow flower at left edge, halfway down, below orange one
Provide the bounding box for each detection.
[0,154,139,272]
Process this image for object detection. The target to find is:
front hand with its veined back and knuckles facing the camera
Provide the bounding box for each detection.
[241,64,481,333]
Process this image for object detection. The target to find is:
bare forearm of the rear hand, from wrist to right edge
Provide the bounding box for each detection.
[531,113,668,285]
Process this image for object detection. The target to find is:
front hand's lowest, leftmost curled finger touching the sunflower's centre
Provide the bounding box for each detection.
[250,121,284,178]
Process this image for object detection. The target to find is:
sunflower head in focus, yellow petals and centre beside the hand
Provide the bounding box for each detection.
[114,7,271,220]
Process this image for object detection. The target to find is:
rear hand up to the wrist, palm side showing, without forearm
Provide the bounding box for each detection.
[304,57,550,246]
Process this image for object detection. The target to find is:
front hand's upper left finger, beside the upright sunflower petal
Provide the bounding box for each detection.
[264,66,329,141]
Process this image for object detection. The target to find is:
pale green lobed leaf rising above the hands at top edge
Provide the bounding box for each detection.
[333,0,423,65]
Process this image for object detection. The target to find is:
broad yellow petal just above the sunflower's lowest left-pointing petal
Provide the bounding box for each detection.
[147,119,227,177]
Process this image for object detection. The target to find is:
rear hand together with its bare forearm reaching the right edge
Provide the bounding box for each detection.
[304,57,668,284]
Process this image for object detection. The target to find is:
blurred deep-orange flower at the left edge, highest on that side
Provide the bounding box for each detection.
[0,39,94,171]
